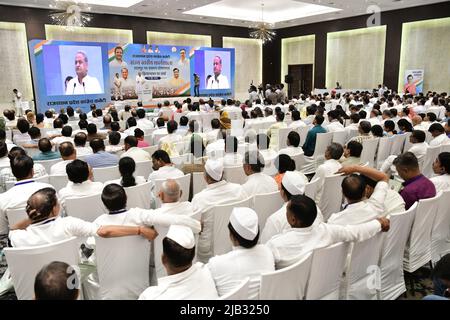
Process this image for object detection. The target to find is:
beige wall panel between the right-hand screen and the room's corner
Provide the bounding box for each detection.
[223,37,262,102]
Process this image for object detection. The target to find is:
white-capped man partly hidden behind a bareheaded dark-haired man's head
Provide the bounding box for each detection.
[261,171,323,243]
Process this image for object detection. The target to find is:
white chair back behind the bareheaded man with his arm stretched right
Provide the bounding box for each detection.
[259,253,312,300]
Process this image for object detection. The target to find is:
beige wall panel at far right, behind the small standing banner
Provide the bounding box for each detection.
[398,18,450,92]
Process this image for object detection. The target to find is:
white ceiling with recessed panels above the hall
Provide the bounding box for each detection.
[0,0,444,28]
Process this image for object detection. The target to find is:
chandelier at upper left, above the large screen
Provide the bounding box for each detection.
[49,0,92,30]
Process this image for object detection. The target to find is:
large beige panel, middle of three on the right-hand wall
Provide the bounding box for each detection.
[326,26,386,89]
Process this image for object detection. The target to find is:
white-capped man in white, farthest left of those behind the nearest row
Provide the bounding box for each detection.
[192,159,248,263]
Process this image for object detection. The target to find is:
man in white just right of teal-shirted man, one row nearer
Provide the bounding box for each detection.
[311,143,344,203]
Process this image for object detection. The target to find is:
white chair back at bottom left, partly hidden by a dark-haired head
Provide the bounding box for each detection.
[3,237,79,300]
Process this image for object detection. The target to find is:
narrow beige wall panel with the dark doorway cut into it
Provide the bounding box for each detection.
[280,35,316,87]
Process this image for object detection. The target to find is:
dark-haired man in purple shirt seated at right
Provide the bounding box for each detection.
[394,152,436,210]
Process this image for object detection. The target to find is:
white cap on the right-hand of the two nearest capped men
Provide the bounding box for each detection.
[230,208,258,241]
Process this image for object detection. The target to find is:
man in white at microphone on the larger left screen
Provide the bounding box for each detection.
[66,51,103,94]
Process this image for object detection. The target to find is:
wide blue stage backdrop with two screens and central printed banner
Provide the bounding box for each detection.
[29,40,235,112]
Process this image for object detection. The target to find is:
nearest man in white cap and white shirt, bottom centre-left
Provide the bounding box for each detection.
[139,225,218,300]
